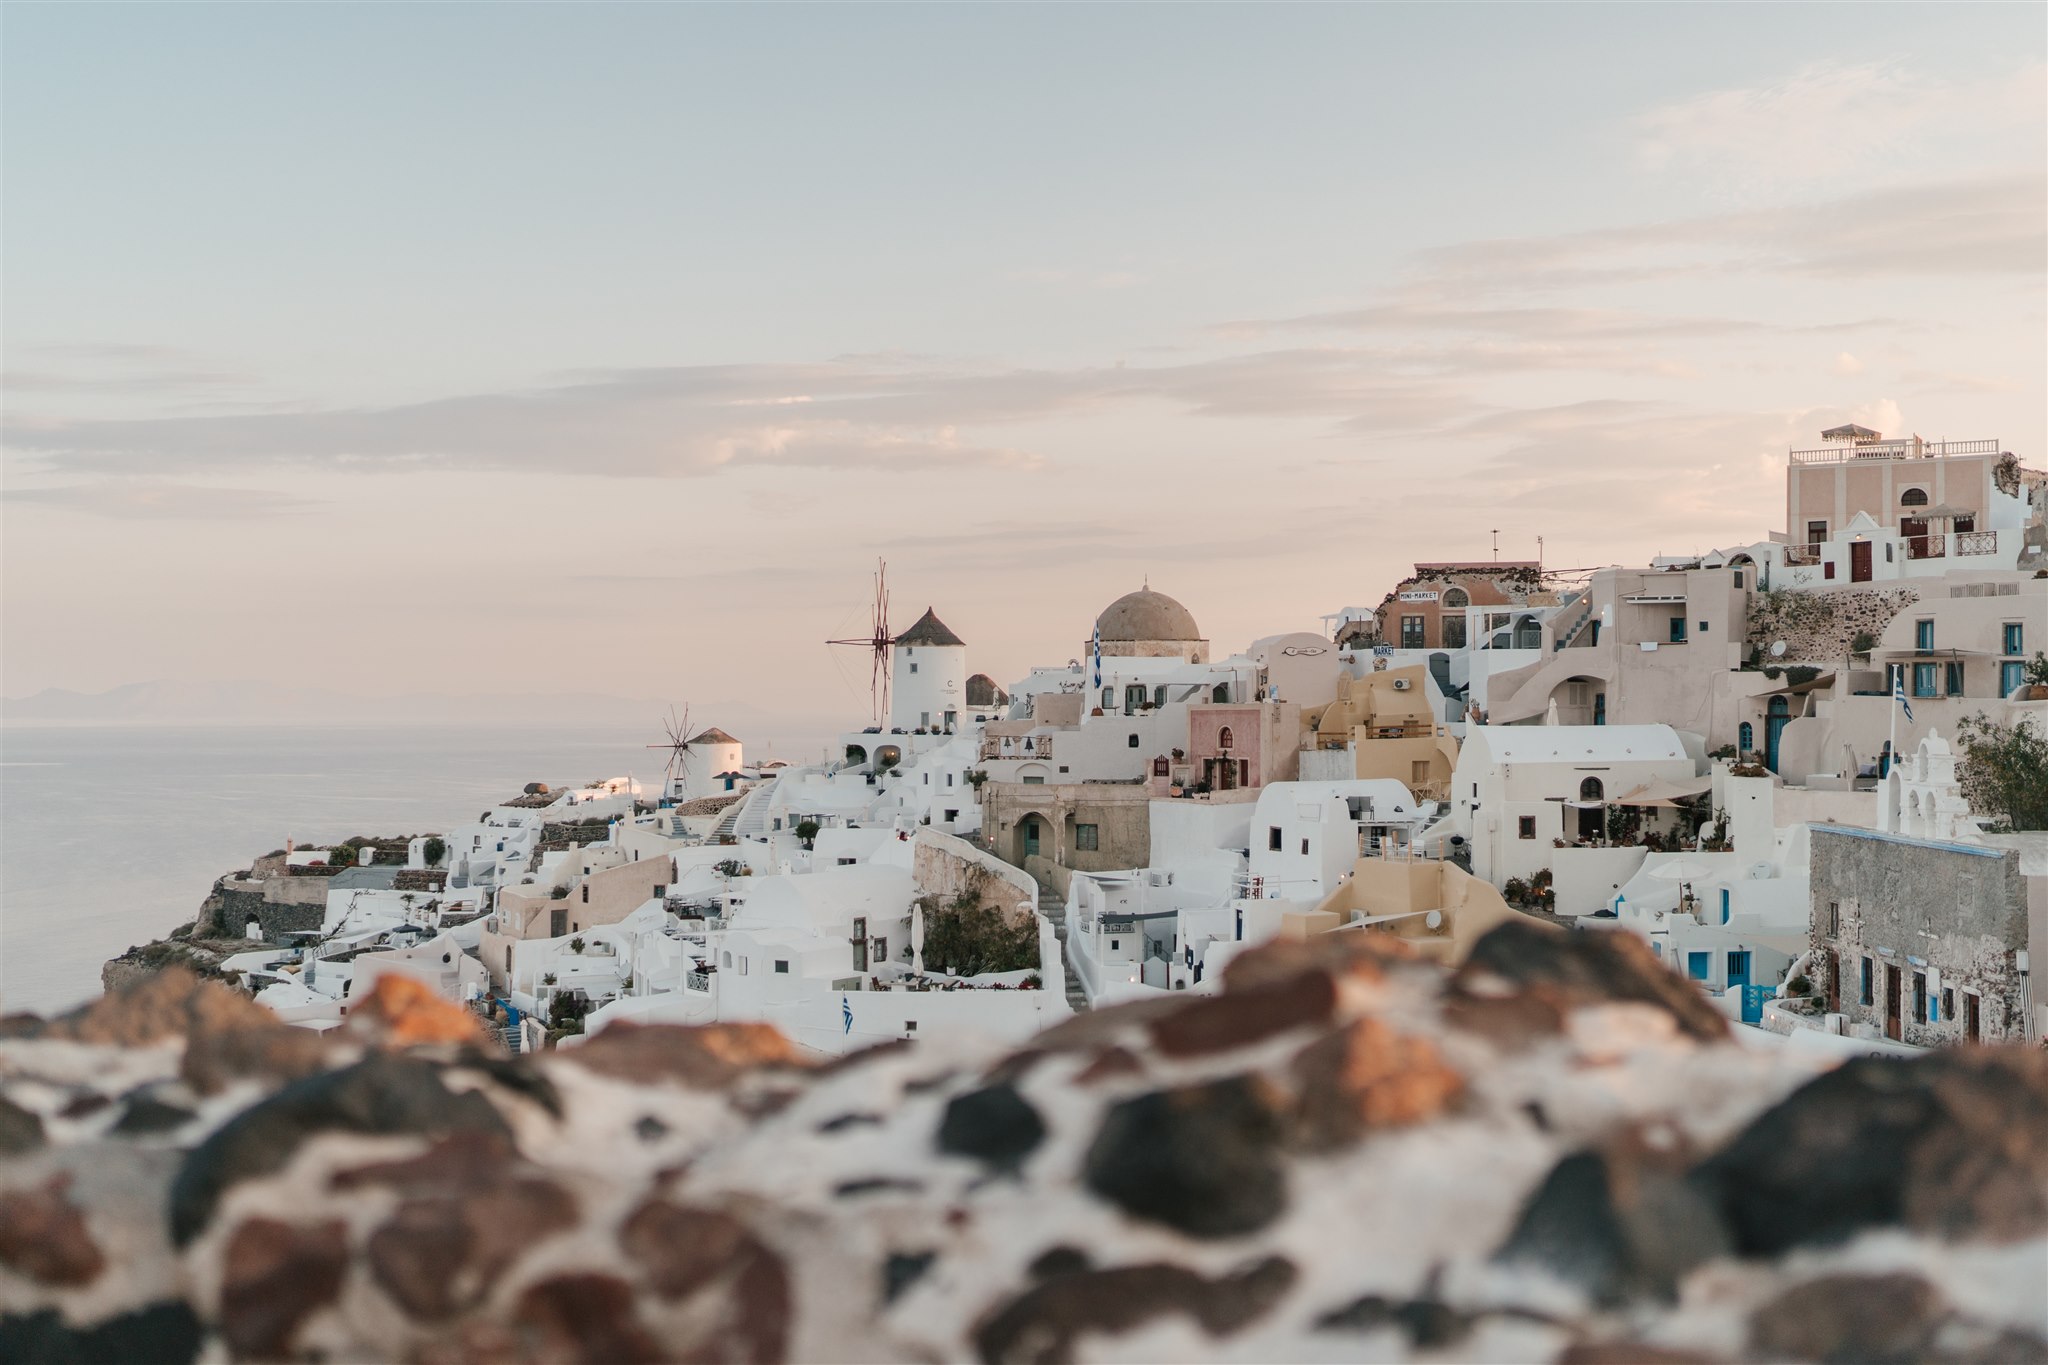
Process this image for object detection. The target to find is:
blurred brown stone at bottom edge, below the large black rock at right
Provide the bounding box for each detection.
[1749,1275,1948,1365]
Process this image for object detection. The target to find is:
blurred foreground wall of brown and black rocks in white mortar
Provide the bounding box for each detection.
[0,925,2048,1365]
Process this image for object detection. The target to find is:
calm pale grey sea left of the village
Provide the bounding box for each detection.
[0,726,664,1013]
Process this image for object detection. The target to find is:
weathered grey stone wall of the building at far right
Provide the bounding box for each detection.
[1808,825,2028,1048]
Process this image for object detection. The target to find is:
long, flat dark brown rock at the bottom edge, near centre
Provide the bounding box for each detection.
[975,1257,1296,1365]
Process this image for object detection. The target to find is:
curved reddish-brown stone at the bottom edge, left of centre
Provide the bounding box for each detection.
[618,1199,791,1365]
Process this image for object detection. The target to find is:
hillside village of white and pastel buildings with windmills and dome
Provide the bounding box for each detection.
[163,426,2048,1054]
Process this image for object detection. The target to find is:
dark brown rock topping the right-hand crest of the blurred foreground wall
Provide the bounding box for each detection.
[1458,919,1729,1042]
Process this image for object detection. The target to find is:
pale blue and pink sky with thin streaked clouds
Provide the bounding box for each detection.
[0,4,2048,736]
